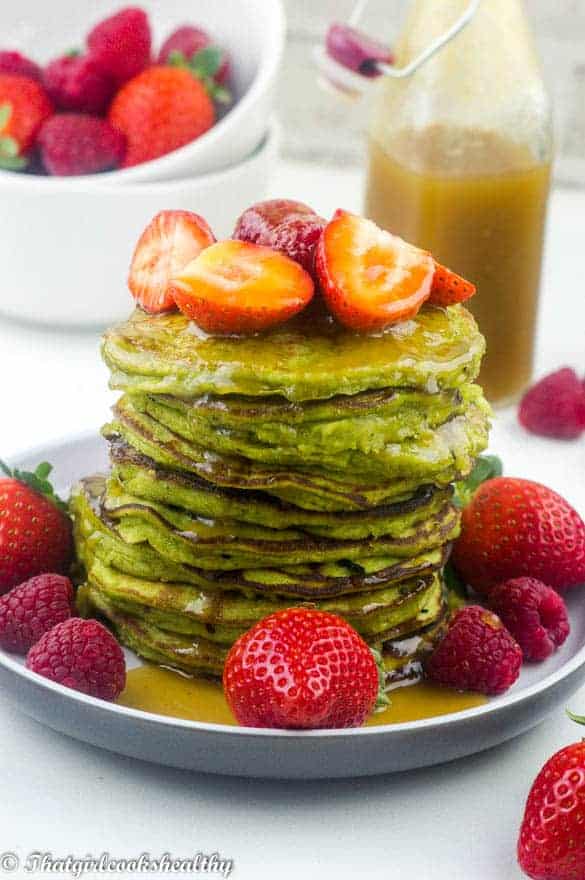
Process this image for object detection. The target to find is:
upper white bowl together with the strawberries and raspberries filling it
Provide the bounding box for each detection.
[0,0,284,185]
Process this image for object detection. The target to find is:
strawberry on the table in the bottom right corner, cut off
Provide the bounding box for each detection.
[518,736,585,880]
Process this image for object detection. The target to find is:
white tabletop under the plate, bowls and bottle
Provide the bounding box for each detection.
[0,163,585,880]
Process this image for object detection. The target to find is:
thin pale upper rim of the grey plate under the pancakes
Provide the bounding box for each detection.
[6,430,585,740]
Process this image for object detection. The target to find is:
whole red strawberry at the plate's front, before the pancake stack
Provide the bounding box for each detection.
[223,608,379,729]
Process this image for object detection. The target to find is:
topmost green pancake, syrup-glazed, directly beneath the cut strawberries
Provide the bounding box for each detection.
[102,306,485,401]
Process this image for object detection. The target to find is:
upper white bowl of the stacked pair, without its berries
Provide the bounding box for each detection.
[0,0,285,182]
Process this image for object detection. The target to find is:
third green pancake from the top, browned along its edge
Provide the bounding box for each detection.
[104,396,489,510]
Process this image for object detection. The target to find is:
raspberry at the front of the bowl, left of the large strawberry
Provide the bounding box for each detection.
[38,113,126,176]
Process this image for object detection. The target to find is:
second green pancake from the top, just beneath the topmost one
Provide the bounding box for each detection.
[131,385,490,480]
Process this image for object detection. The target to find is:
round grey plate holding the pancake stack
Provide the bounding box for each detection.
[0,435,585,779]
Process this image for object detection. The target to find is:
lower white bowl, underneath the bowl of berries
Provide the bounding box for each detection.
[0,124,279,327]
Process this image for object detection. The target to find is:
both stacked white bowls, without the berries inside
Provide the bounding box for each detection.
[0,0,285,326]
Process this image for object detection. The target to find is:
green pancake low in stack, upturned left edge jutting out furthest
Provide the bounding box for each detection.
[71,477,449,600]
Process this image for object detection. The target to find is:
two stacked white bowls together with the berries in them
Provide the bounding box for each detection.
[0,0,284,326]
